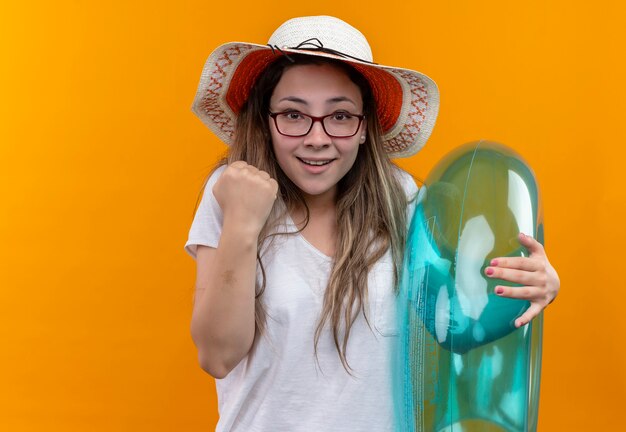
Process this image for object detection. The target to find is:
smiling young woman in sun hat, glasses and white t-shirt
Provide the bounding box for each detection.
[185,17,559,431]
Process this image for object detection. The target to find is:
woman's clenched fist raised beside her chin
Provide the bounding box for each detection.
[213,161,278,236]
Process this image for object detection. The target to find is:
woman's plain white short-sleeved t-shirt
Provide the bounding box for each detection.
[185,167,417,432]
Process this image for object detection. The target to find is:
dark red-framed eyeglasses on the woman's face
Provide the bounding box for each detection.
[269,111,365,138]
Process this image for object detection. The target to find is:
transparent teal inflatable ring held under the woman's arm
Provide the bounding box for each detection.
[394,141,543,432]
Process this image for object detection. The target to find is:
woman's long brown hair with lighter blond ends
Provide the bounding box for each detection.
[196,55,407,372]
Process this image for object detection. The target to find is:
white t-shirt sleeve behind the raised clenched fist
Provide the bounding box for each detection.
[185,165,226,259]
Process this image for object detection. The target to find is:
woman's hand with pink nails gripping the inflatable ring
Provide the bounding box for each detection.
[485,233,561,327]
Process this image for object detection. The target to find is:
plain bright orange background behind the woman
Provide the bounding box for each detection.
[0,0,626,431]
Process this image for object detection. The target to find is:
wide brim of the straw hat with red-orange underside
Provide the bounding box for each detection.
[192,42,439,158]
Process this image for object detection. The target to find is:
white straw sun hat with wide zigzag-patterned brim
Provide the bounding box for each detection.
[192,16,439,158]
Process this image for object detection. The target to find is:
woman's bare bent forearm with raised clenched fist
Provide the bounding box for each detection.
[191,162,278,378]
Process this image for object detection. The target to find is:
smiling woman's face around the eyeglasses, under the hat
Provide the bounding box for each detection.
[269,64,366,203]
